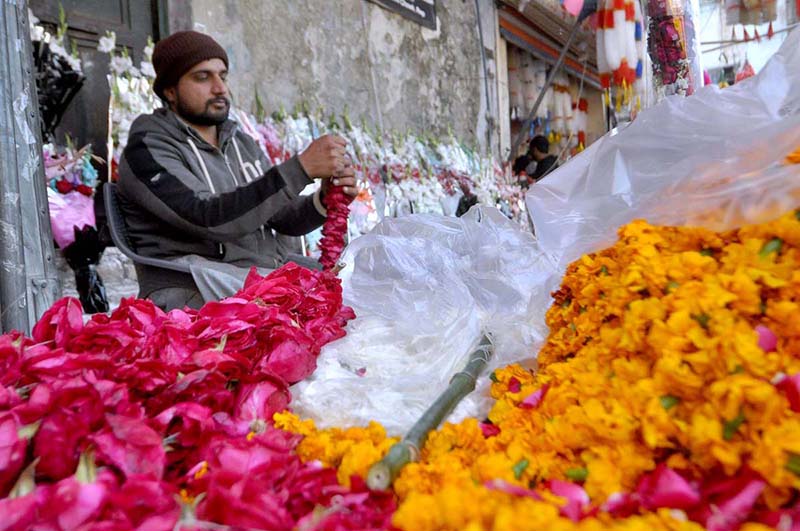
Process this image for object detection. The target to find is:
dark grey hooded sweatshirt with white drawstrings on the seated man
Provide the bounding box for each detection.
[118,109,325,297]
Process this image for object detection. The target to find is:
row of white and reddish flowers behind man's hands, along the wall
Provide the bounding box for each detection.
[233,109,526,246]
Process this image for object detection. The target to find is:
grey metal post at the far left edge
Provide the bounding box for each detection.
[0,0,60,333]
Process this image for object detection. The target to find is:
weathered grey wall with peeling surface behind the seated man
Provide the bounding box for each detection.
[169,0,499,157]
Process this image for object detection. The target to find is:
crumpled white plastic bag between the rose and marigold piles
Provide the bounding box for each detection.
[292,207,558,434]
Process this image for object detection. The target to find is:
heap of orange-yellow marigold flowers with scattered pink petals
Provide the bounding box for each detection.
[274,207,800,531]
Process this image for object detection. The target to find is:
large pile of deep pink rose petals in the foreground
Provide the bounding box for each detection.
[0,264,395,531]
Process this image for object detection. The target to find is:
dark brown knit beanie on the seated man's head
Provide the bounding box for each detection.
[153,31,228,100]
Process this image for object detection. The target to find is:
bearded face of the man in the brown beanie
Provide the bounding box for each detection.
[164,58,231,126]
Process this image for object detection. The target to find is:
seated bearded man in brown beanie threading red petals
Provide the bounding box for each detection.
[118,31,357,310]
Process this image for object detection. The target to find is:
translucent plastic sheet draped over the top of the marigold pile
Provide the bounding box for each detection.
[526,29,800,268]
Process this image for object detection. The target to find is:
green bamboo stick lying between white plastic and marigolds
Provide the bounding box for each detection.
[367,335,493,490]
